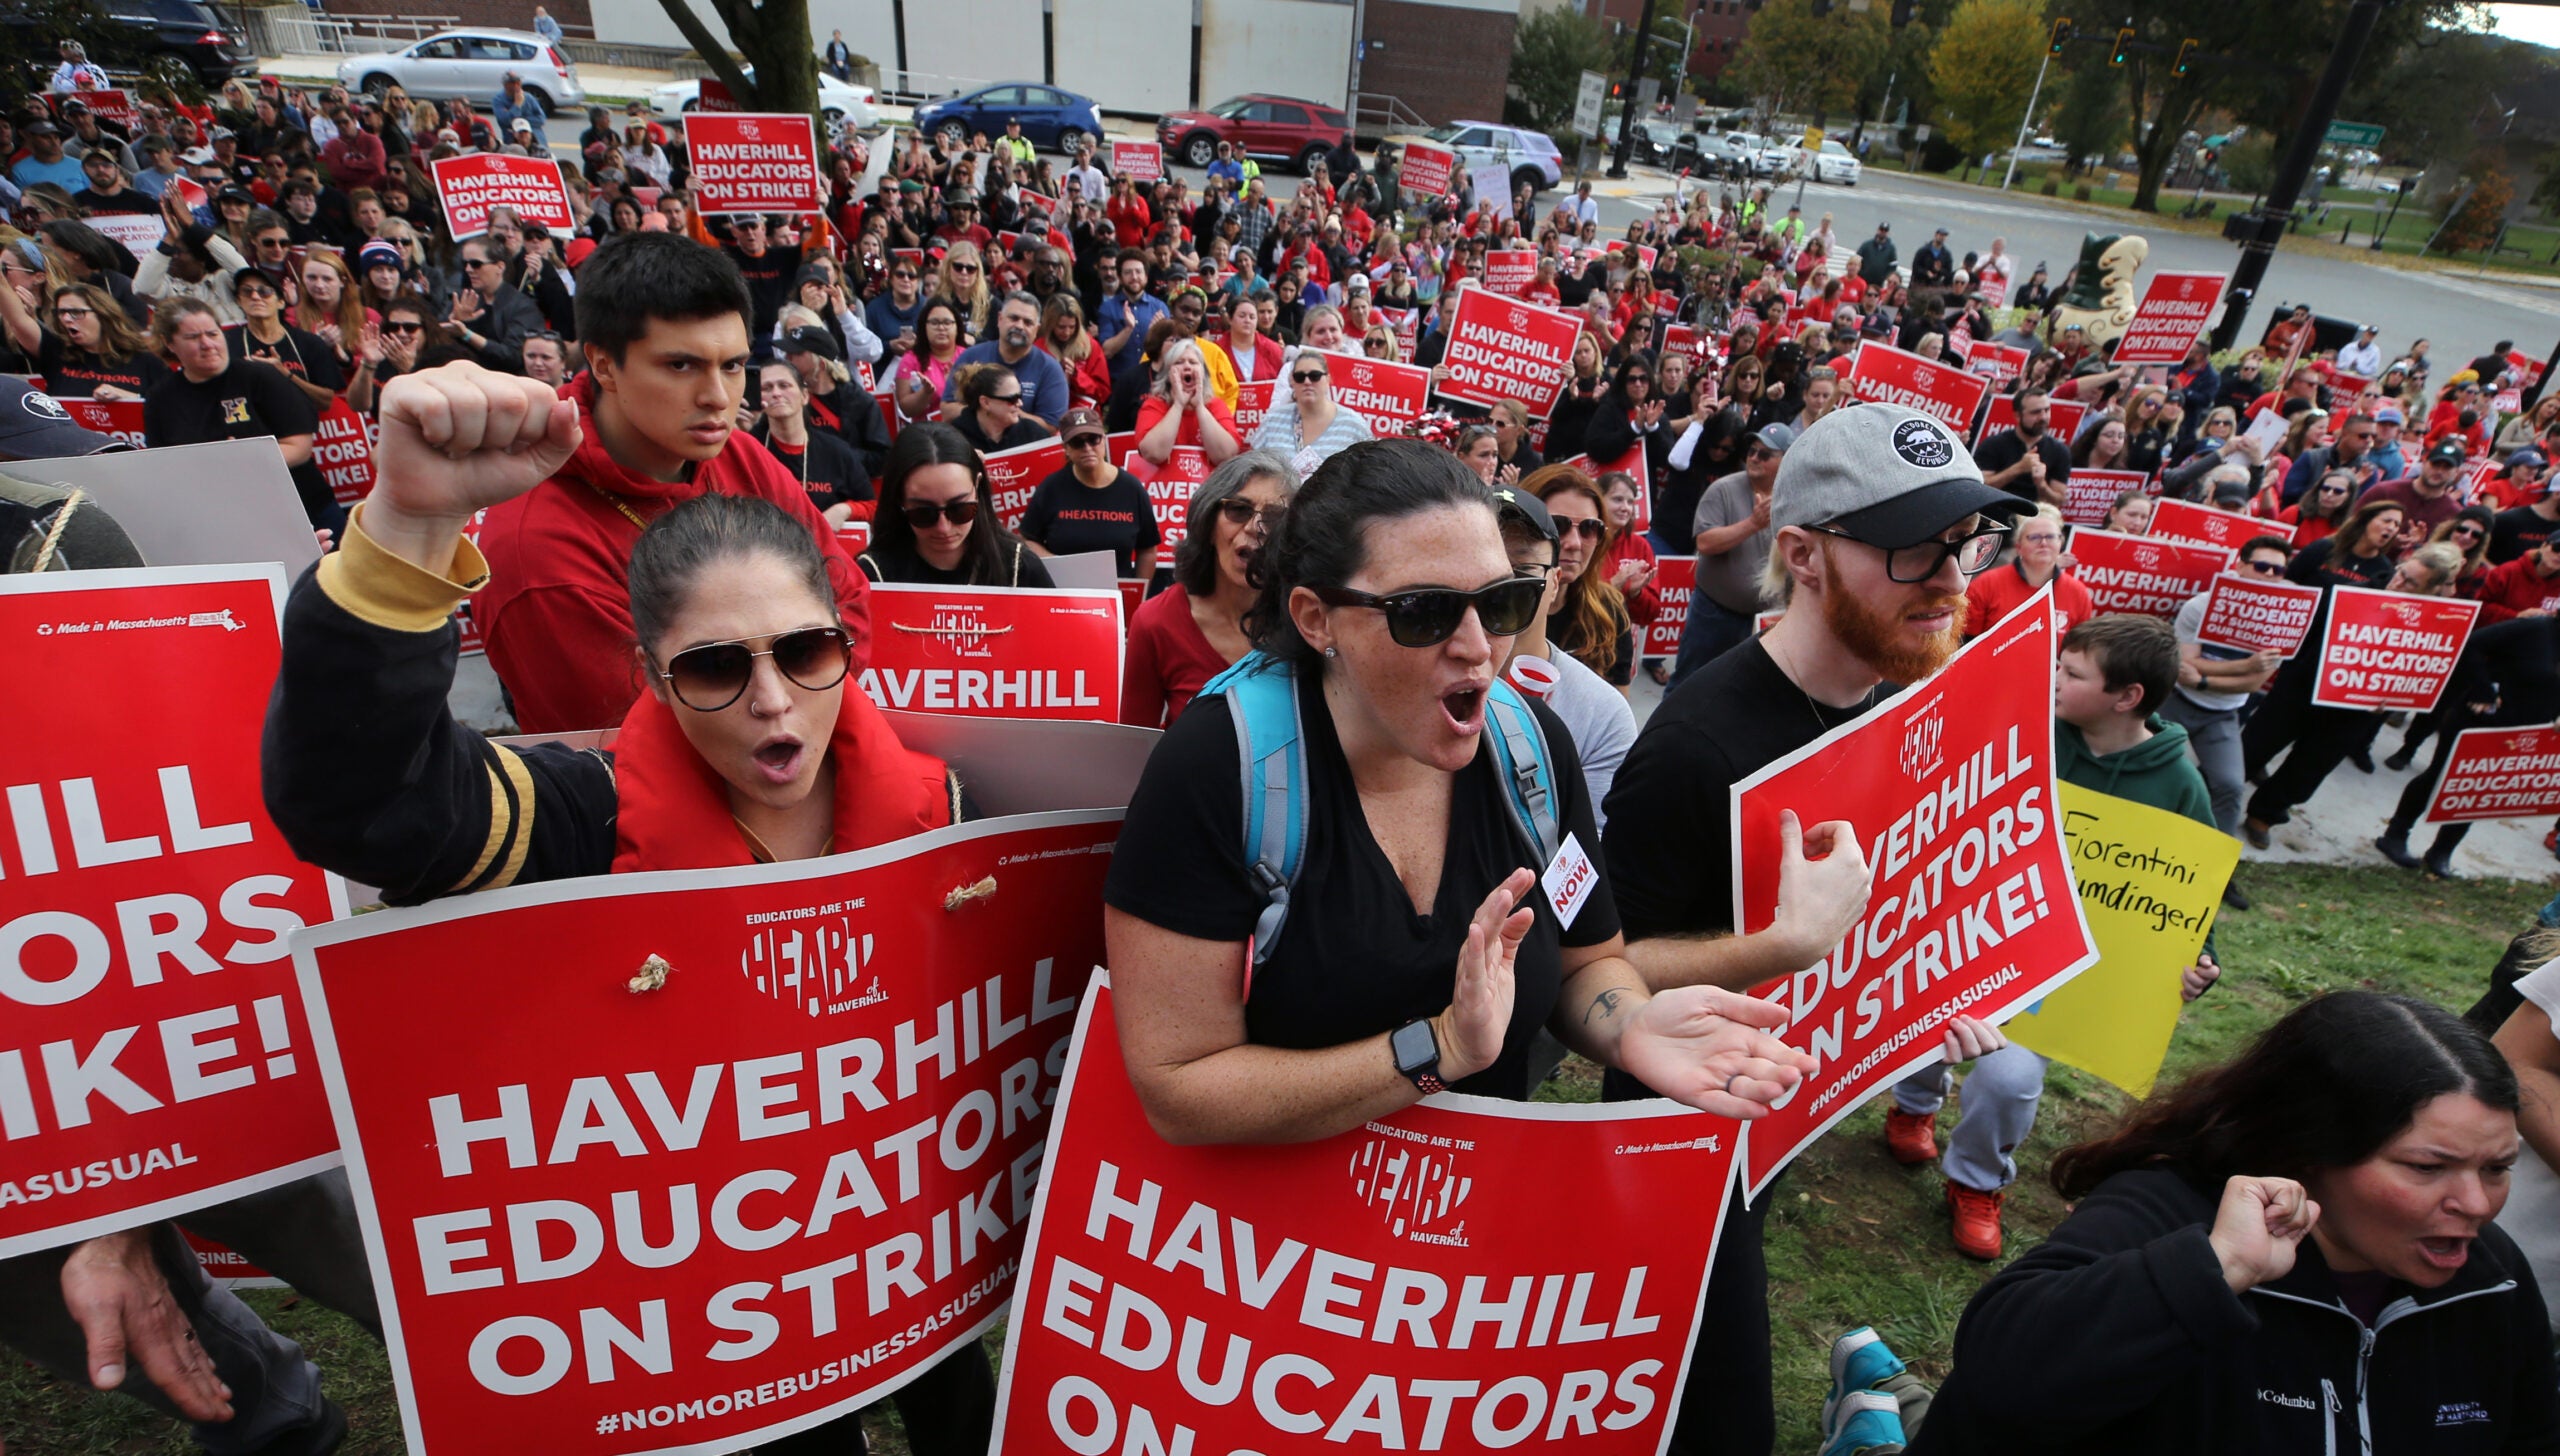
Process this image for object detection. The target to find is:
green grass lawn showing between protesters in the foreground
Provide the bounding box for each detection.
[0,865,2550,1456]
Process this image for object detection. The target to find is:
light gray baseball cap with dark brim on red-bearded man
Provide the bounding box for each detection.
[1769,404,2028,550]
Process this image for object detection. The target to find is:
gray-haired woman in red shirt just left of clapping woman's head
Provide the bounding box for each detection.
[1121,450,1298,727]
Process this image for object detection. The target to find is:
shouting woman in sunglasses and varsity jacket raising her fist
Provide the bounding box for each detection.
[264,366,996,1451]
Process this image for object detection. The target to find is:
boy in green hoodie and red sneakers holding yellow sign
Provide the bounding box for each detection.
[1884,614,2222,1259]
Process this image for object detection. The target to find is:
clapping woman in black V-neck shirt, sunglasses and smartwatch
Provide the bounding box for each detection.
[1103,440,1807,1144]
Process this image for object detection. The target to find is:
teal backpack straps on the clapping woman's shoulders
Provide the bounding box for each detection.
[1201,653,1564,967]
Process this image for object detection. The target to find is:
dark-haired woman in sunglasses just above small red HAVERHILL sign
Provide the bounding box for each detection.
[858,422,1055,586]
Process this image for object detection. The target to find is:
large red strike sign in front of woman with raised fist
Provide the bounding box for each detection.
[294,811,1119,1456]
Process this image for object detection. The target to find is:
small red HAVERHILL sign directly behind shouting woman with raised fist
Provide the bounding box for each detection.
[863,581,1121,722]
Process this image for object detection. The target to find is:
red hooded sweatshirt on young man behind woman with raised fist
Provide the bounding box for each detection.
[471,374,870,732]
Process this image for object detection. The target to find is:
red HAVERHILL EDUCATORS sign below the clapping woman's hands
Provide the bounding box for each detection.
[993,985,1738,1456]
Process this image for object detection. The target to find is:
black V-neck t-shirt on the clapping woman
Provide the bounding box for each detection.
[1103,683,1618,1100]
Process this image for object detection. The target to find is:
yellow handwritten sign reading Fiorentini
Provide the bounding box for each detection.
[2002,783,2240,1098]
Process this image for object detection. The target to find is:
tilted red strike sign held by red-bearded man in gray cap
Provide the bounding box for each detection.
[1733,586,2097,1195]
